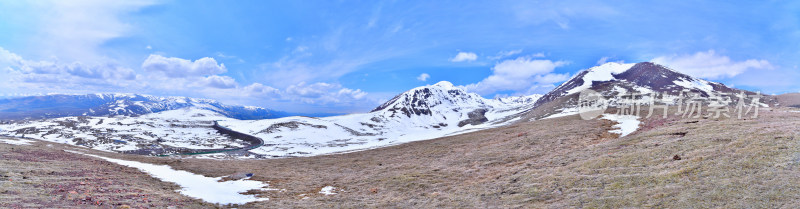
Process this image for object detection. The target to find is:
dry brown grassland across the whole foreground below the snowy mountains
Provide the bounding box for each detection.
[0,109,800,208]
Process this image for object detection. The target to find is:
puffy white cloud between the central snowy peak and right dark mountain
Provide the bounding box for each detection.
[464,57,569,94]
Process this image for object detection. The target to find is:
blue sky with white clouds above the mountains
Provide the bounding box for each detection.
[0,0,800,113]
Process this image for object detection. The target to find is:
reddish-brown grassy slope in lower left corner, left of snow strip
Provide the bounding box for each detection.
[0,139,213,208]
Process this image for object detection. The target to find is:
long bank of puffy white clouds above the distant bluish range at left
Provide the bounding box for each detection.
[0,47,372,107]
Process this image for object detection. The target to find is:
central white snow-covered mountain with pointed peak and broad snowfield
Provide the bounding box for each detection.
[220,81,537,156]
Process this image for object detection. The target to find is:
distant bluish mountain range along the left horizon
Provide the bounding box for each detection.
[0,94,288,120]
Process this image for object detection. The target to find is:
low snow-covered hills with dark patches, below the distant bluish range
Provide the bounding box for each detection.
[0,107,246,152]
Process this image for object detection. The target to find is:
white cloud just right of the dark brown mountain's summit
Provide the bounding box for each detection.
[652,50,774,79]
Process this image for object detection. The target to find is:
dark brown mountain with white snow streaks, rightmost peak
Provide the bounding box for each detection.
[530,62,774,119]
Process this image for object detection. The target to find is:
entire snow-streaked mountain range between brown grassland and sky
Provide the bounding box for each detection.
[0,62,777,157]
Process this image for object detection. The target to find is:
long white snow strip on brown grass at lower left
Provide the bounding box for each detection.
[64,150,276,205]
